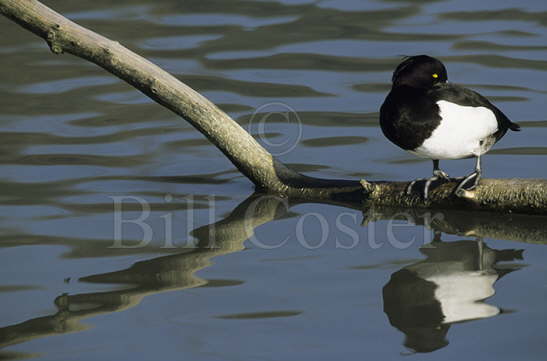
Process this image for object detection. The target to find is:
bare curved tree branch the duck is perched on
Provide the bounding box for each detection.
[0,0,547,214]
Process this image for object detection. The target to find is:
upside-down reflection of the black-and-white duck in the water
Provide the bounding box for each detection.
[383,233,523,352]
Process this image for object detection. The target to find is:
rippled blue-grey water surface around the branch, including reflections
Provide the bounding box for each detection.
[0,0,547,360]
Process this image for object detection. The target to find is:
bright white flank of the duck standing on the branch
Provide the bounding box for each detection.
[411,100,498,159]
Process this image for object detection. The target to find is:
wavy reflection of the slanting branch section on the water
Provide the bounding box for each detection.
[0,195,288,358]
